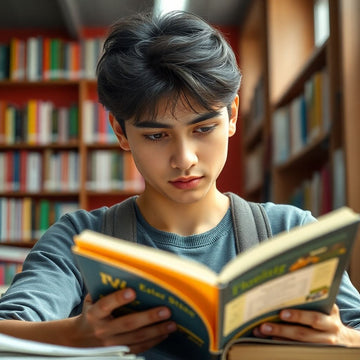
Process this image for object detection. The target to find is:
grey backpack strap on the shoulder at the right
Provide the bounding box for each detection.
[226,193,272,253]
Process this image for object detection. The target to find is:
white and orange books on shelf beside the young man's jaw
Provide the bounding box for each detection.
[86,150,144,191]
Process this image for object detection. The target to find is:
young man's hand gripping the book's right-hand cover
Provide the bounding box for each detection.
[254,305,360,346]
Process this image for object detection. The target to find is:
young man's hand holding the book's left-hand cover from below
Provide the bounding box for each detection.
[72,289,176,353]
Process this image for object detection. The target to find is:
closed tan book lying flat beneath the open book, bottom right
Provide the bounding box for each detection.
[226,339,360,360]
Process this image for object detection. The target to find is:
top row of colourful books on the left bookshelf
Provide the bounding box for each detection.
[0,36,104,81]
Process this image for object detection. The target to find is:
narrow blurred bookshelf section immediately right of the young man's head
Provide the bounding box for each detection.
[239,0,270,201]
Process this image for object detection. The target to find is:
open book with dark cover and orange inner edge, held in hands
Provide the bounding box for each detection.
[73,207,360,359]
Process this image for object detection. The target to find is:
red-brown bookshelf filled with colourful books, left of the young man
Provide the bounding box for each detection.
[0,29,143,282]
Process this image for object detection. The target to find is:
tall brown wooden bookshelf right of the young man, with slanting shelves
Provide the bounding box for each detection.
[240,0,360,288]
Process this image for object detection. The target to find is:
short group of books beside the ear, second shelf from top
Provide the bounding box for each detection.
[82,100,117,144]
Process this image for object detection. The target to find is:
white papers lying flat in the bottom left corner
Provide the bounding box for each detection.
[0,334,144,360]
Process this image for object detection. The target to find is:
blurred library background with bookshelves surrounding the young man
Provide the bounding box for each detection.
[0,0,360,356]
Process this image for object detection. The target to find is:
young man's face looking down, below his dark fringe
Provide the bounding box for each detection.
[116,98,238,204]
